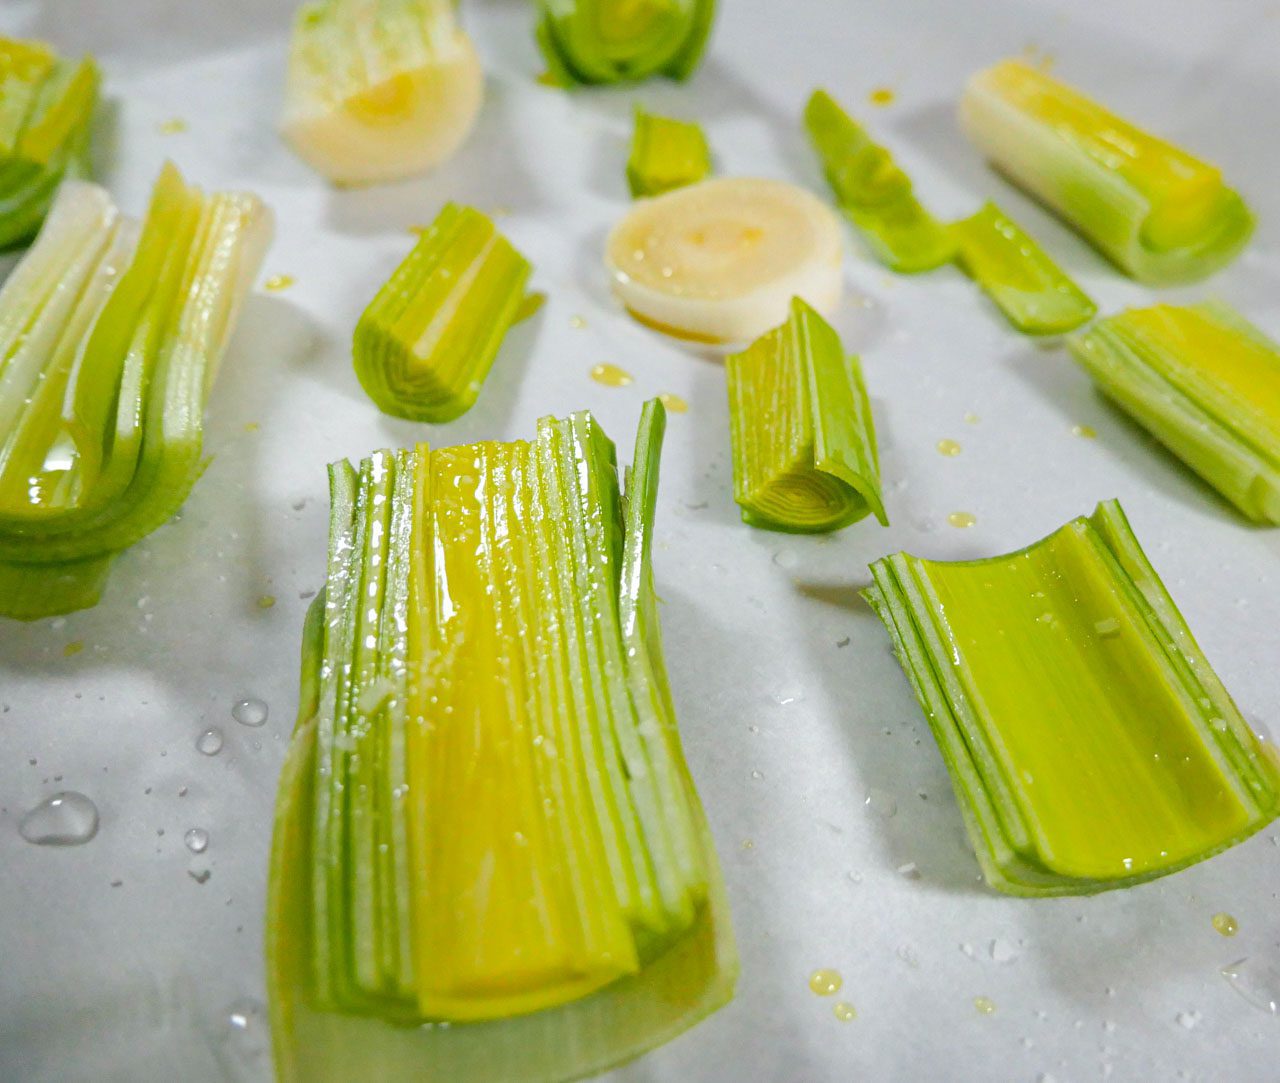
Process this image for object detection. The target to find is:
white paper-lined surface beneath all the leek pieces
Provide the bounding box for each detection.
[0,0,1280,1083]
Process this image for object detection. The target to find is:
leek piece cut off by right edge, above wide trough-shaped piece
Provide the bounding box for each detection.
[1068,301,1280,524]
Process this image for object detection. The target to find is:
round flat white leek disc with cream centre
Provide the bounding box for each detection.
[605,177,844,343]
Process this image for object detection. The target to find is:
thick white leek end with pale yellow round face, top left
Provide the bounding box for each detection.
[282,0,484,184]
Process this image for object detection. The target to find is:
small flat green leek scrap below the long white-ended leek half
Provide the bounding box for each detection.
[951,204,1097,334]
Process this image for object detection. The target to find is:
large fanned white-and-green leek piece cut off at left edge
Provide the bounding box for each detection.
[0,165,270,618]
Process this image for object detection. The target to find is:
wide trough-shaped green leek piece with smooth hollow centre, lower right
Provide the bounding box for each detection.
[864,501,1280,895]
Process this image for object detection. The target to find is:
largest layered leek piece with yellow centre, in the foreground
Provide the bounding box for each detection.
[266,402,737,1083]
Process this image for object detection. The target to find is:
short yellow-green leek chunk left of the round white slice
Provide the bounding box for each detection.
[353,204,532,422]
